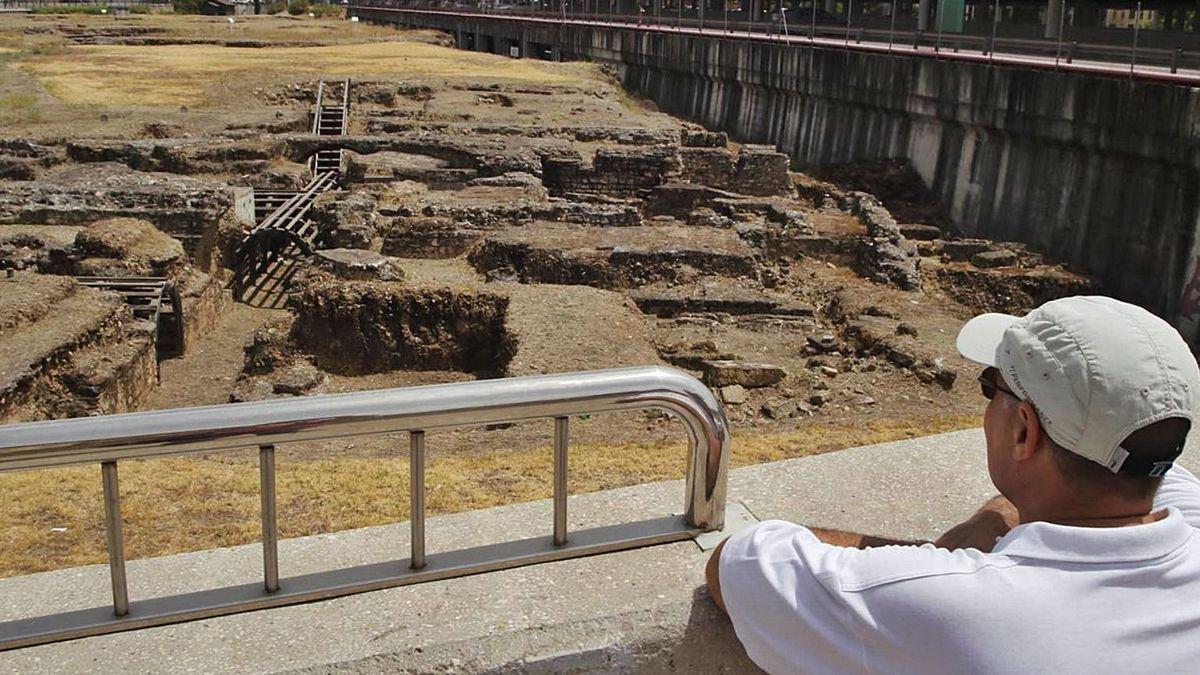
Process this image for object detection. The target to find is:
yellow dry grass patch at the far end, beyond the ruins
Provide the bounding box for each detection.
[18,41,592,107]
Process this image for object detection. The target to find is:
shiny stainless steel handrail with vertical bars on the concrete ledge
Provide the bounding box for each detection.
[0,368,730,650]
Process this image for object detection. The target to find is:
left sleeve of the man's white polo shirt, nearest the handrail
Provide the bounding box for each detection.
[720,520,863,673]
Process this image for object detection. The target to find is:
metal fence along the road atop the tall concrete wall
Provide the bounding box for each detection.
[352,0,1200,73]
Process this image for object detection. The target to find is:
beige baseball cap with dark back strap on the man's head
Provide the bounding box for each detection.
[958,295,1200,476]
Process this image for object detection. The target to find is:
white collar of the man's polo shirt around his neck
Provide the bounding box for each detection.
[992,507,1193,563]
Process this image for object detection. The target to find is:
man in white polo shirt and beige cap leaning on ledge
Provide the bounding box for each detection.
[708,297,1200,673]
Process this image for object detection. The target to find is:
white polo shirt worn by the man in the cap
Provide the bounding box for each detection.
[720,467,1200,674]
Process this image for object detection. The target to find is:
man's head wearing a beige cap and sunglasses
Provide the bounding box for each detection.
[958,297,1200,510]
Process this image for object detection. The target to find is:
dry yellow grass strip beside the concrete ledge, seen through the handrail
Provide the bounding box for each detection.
[0,417,979,577]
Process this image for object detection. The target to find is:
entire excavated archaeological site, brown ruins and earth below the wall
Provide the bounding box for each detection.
[0,16,1098,562]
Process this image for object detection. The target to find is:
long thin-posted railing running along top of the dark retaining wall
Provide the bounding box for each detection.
[352,0,1200,73]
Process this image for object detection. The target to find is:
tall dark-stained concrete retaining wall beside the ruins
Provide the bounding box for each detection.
[355,8,1200,342]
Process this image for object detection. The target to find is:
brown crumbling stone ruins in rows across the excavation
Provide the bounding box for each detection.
[0,72,1093,424]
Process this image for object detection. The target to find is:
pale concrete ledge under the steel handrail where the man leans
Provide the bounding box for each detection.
[0,430,1200,673]
